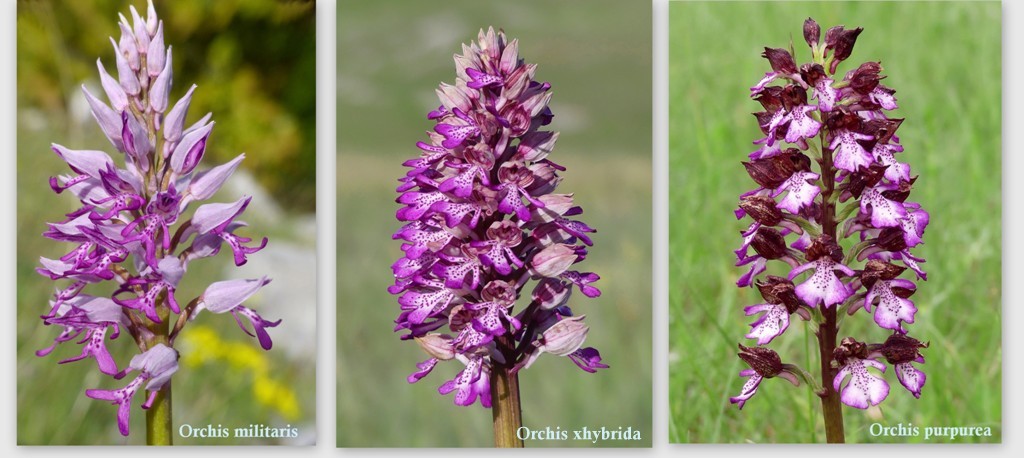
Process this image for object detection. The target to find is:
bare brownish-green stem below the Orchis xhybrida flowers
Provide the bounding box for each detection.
[490,336,525,449]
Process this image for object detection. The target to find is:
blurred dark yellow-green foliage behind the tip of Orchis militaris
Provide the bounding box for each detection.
[17,0,316,212]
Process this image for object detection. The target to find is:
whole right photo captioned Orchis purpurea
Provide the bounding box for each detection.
[669,1,1002,444]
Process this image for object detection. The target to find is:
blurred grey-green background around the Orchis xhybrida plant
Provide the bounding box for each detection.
[337,0,651,447]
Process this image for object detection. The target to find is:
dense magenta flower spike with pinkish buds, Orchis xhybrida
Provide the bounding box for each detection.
[389,29,607,407]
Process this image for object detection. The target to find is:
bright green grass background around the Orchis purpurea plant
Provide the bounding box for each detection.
[669,2,1002,443]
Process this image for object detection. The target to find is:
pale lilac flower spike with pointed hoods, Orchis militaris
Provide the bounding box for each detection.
[37,1,280,435]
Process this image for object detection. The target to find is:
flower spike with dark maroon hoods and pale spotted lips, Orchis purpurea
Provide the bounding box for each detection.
[730,18,929,409]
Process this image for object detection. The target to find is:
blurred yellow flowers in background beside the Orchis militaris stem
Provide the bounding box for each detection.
[181,326,301,420]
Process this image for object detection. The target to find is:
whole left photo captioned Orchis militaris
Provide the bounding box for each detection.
[16,0,316,446]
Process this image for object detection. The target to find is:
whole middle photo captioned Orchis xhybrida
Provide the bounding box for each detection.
[337,0,652,447]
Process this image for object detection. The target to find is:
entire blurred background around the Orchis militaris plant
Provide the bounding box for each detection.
[17,0,316,445]
